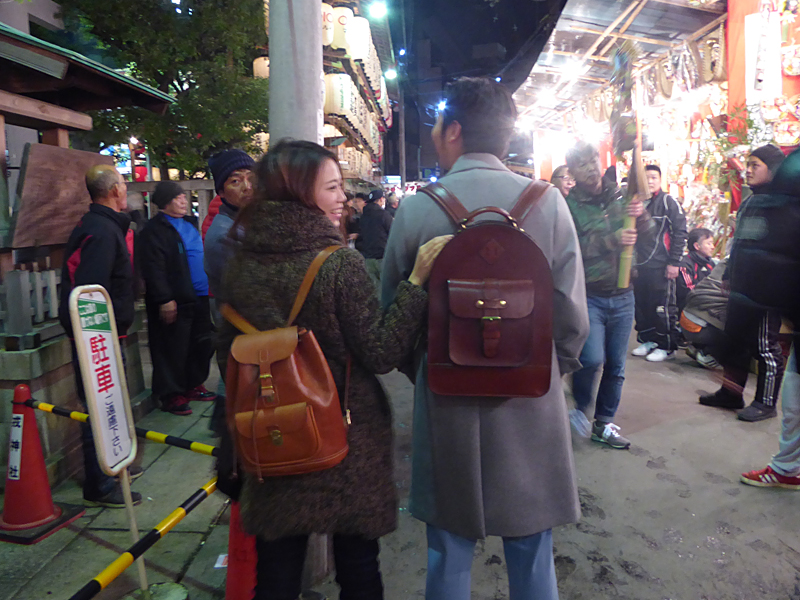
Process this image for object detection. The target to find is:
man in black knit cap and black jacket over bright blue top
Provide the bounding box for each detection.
[138,181,216,415]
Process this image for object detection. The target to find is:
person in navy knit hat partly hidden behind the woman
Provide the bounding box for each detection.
[204,150,255,434]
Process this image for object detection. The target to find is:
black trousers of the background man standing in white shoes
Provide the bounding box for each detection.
[633,267,680,352]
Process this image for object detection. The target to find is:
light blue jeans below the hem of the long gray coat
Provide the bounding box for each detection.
[425,525,558,600]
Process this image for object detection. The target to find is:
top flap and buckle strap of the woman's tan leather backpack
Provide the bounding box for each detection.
[231,327,298,402]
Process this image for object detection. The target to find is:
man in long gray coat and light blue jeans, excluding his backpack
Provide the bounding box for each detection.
[381,78,589,600]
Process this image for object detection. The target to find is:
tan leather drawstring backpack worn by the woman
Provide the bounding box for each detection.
[220,246,350,480]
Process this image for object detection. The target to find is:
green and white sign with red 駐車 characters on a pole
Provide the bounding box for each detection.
[69,285,136,475]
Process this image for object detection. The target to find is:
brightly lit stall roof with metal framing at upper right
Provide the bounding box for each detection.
[514,0,727,129]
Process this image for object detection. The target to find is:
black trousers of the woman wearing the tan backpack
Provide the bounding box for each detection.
[255,534,383,600]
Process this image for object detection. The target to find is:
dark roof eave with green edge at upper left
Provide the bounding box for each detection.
[0,23,174,126]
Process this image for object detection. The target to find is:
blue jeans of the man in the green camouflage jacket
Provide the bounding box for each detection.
[572,291,635,423]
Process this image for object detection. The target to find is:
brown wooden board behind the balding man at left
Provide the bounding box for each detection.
[9,144,114,248]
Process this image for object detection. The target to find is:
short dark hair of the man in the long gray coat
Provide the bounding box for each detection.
[442,77,517,158]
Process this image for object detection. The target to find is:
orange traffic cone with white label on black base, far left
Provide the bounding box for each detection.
[0,385,86,544]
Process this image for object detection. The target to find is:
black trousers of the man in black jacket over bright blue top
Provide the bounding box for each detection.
[147,296,214,402]
